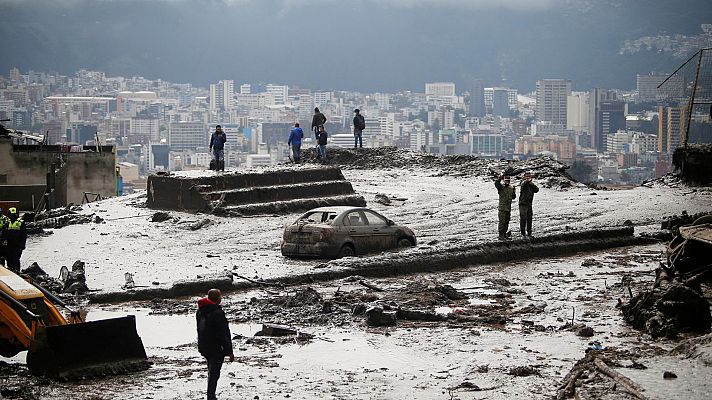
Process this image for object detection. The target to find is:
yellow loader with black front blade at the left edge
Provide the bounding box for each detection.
[0,267,149,379]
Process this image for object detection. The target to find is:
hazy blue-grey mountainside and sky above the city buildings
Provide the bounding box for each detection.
[0,0,712,91]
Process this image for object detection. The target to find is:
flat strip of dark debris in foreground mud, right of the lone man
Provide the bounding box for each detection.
[229,276,511,327]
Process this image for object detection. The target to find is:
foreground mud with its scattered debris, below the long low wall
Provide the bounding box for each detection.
[0,245,712,399]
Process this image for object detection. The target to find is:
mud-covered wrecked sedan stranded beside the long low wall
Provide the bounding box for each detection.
[282,206,416,258]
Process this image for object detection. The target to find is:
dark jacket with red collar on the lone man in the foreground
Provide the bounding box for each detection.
[195,297,232,358]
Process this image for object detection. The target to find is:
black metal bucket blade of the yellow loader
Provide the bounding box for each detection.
[27,315,150,380]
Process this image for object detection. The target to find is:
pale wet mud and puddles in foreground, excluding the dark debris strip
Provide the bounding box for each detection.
[1,246,680,399]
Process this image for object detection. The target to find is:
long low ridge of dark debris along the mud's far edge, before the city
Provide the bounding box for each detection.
[302,147,576,187]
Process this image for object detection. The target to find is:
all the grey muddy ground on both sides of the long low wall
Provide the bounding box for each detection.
[0,151,712,399]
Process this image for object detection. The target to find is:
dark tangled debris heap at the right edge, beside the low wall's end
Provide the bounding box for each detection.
[619,215,712,338]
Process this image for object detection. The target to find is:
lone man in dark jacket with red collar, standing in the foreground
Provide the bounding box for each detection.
[195,289,235,400]
